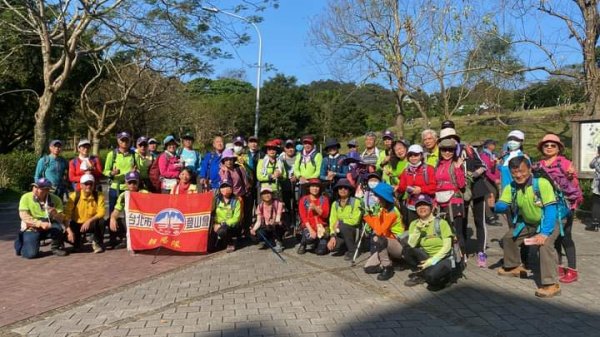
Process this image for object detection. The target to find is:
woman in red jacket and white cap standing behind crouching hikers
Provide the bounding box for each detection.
[396,144,436,226]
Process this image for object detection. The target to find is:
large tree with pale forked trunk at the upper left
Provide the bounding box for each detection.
[0,0,270,154]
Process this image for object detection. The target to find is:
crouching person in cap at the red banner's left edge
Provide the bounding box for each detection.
[108,171,148,249]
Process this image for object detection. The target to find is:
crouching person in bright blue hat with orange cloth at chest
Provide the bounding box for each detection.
[364,182,404,281]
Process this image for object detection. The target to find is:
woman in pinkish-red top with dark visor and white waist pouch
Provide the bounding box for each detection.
[435,138,467,252]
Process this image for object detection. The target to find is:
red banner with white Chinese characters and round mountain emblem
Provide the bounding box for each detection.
[125,192,213,253]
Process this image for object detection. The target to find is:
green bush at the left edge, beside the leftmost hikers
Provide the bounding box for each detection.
[0,151,38,191]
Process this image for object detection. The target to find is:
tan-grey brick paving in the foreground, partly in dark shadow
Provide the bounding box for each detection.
[0,213,600,337]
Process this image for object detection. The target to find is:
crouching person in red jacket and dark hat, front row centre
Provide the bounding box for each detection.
[298,178,329,255]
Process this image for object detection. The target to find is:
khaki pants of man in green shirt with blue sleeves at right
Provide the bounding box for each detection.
[502,223,560,285]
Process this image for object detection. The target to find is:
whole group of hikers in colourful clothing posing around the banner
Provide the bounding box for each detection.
[15,121,600,297]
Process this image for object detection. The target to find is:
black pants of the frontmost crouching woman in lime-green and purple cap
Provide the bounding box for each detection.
[402,245,452,286]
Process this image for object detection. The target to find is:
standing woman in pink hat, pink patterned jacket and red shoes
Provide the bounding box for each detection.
[535,134,583,283]
